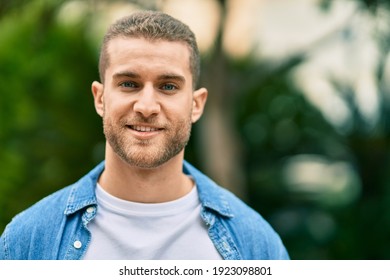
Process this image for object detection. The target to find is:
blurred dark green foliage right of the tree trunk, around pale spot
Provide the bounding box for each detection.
[237,73,390,259]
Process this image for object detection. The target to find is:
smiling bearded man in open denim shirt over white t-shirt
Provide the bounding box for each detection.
[0,11,288,259]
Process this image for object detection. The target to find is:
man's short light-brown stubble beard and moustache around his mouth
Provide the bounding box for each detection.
[103,112,192,169]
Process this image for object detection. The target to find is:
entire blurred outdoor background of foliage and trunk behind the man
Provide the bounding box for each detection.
[0,0,390,259]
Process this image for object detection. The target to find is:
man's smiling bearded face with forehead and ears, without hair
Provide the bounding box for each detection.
[92,38,207,168]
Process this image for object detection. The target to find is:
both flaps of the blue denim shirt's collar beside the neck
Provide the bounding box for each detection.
[65,161,233,218]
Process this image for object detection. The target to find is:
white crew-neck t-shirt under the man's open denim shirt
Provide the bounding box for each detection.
[84,184,222,260]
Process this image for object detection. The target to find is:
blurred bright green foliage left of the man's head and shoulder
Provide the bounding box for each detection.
[0,1,103,231]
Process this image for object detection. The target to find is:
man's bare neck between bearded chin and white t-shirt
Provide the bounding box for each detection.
[98,145,193,203]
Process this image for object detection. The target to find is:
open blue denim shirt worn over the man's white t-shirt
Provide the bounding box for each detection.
[0,161,289,260]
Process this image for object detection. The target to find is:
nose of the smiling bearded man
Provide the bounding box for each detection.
[133,86,161,118]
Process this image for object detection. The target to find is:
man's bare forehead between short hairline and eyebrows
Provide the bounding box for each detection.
[106,37,191,78]
